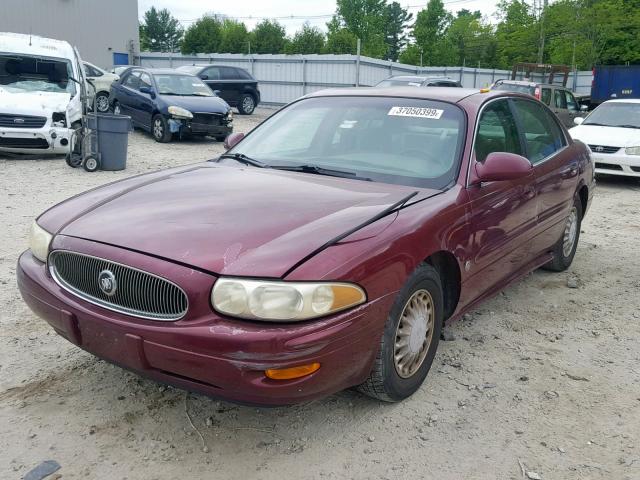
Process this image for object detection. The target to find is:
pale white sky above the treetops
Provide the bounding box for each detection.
[138,0,498,35]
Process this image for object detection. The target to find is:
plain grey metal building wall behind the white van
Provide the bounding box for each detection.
[0,0,140,68]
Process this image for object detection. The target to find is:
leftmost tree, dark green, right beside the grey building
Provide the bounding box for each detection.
[139,7,184,52]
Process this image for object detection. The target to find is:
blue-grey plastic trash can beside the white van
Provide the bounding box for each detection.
[87,113,131,170]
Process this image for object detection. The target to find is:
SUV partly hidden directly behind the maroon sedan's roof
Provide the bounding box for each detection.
[491,80,587,128]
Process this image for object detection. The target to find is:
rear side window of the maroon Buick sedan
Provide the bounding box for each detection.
[514,98,565,165]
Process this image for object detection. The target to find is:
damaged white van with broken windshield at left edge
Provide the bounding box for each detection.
[0,32,86,154]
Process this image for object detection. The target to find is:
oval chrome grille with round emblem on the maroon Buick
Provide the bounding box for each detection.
[49,250,188,321]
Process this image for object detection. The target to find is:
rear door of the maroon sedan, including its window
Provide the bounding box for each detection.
[513,96,578,256]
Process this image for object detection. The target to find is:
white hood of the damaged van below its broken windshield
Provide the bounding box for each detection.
[0,86,71,117]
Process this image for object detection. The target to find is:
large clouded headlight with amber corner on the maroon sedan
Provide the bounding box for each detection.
[211,278,367,322]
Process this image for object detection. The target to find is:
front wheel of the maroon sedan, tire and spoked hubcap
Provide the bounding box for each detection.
[358,264,444,402]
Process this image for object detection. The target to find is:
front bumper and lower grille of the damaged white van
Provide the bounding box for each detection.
[0,125,73,155]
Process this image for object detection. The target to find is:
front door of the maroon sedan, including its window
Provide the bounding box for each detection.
[467,99,537,301]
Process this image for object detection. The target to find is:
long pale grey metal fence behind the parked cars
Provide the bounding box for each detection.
[138,52,592,105]
